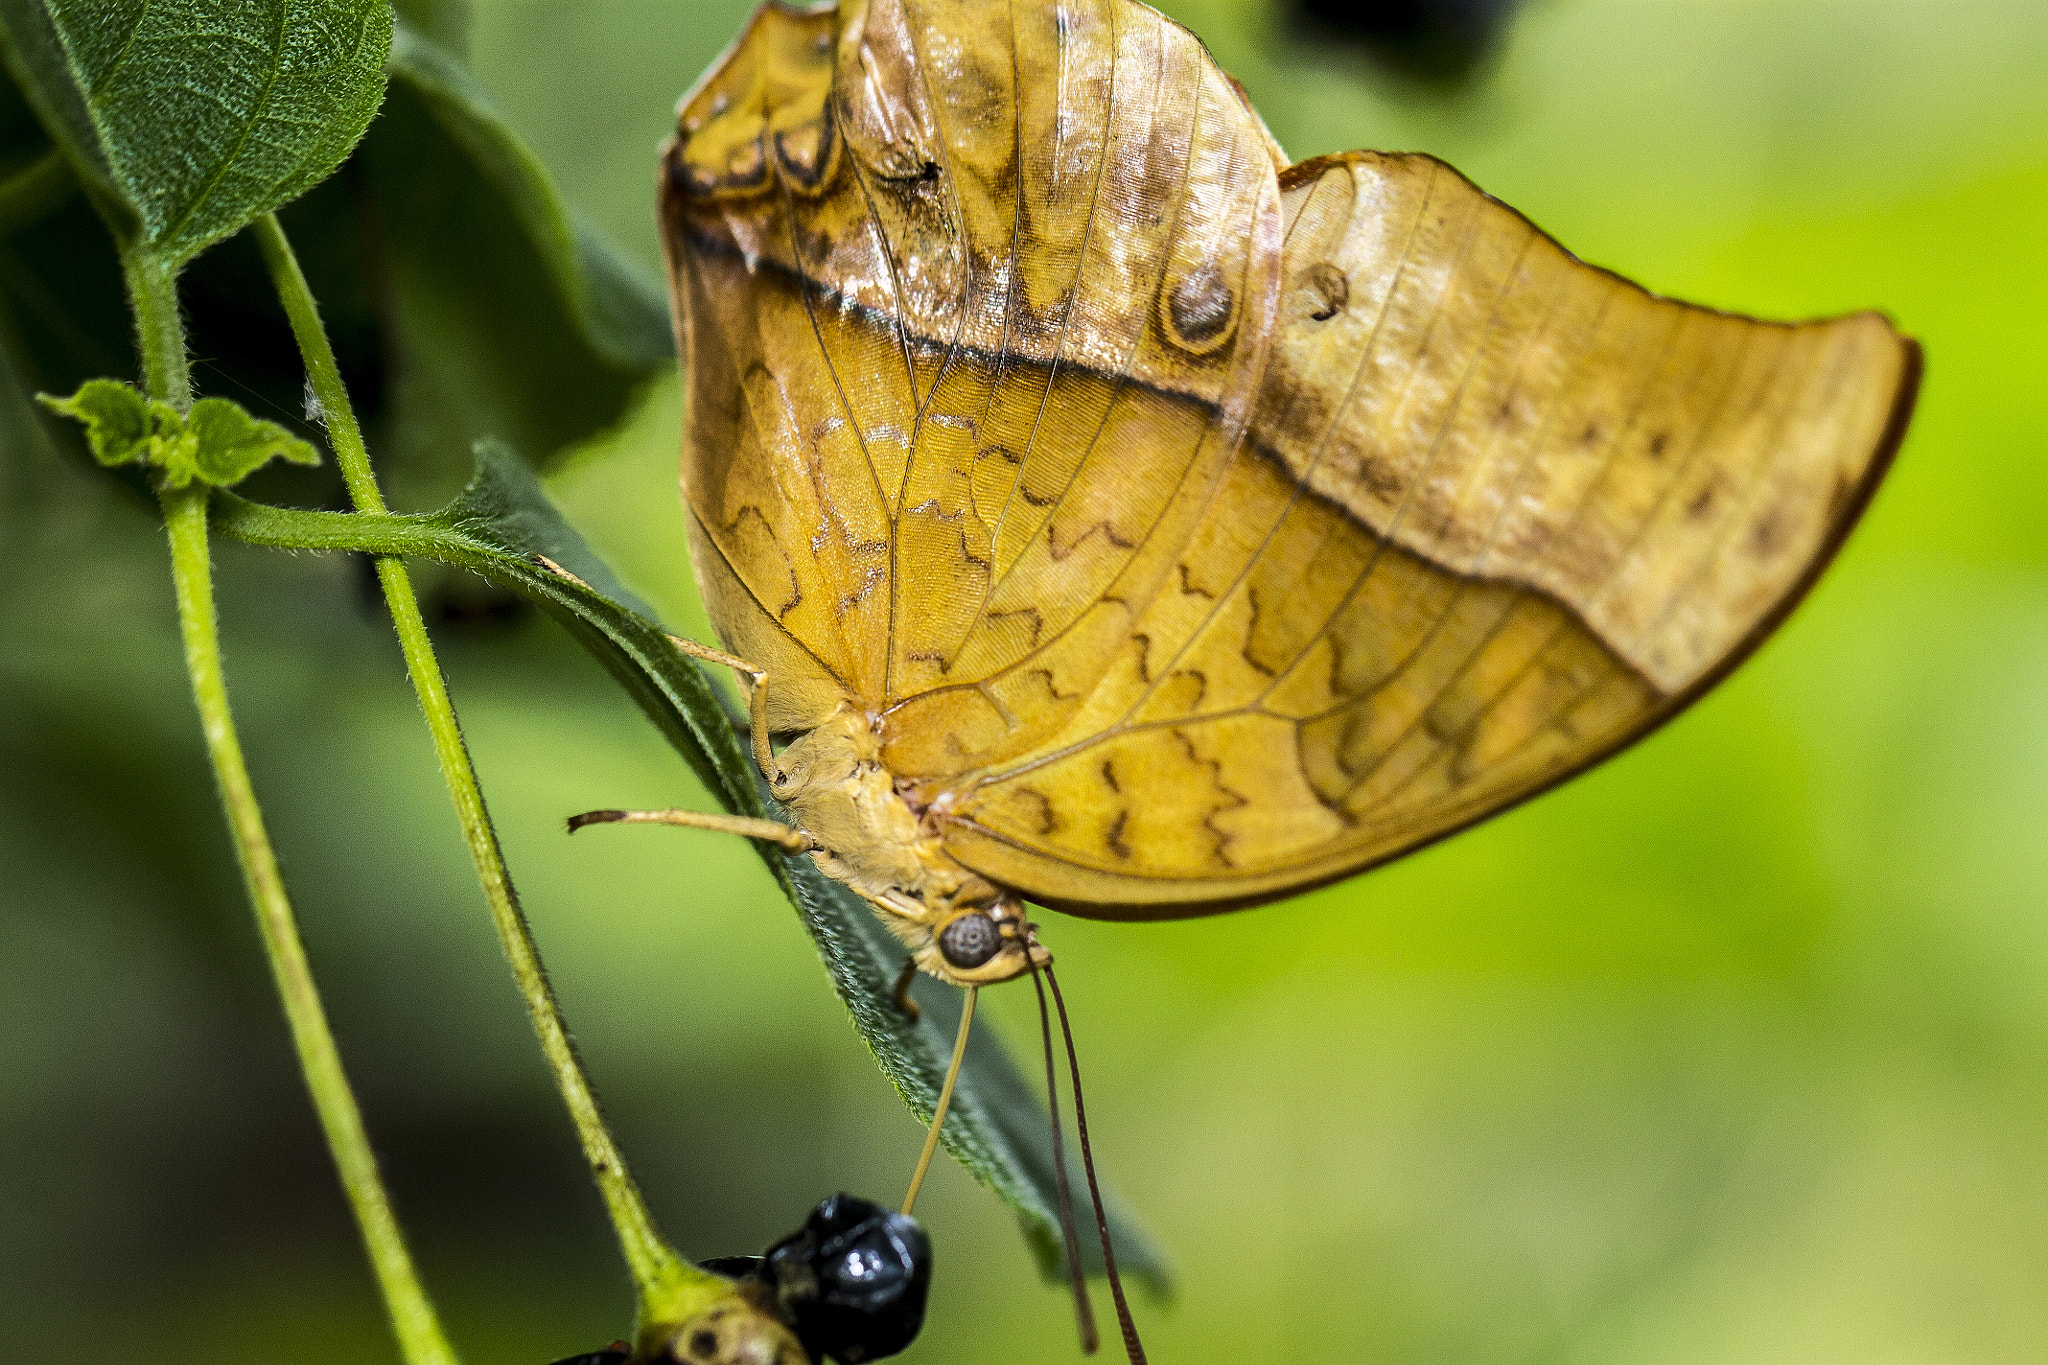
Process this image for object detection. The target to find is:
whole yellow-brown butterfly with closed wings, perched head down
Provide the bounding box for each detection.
[581,0,1919,1358]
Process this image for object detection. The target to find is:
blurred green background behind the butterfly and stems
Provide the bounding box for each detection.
[0,0,2048,1365]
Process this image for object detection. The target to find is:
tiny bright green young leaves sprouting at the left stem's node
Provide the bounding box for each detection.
[37,379,319,489]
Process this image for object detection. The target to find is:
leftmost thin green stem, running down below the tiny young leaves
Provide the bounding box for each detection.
[160,480,455,1365]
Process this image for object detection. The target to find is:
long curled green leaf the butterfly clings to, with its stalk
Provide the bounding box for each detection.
[215,448,1165,1289]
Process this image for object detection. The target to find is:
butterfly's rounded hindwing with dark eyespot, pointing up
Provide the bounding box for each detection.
[664,0,1282,749]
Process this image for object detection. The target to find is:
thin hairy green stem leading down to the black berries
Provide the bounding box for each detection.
[254,213,700,1306]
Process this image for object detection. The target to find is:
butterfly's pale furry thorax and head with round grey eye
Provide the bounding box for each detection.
[768,704,1051,986]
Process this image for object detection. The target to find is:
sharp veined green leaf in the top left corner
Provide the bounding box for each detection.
[0,0,391,266]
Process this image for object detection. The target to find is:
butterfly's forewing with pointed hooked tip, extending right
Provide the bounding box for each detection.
[948,153,1919,917]
